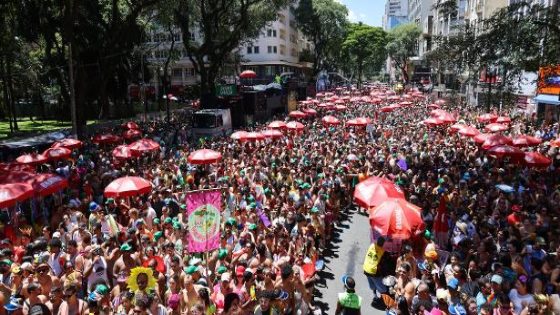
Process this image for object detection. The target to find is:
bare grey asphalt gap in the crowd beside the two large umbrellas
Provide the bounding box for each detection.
[314,209,385,315]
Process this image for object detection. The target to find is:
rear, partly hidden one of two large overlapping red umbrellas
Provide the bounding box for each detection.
[354,176,404,208]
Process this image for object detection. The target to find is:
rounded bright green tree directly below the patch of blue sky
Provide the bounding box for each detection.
[342,23,387,86]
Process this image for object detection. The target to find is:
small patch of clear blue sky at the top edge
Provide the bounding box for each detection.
[336,0,386,26]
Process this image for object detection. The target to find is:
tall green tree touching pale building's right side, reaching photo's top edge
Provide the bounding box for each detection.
[295,0,348,74]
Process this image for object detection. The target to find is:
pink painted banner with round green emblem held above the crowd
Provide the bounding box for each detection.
[186,190,222,253]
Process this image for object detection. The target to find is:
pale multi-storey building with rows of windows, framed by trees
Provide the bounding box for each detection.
[239,8,313,82]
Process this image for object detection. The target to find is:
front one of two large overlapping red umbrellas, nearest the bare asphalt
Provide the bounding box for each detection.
[369,198,424,239]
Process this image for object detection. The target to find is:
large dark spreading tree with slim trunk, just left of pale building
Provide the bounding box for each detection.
[174,0,291,107]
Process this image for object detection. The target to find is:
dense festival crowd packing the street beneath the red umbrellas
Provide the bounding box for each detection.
[0,86,560,315]
